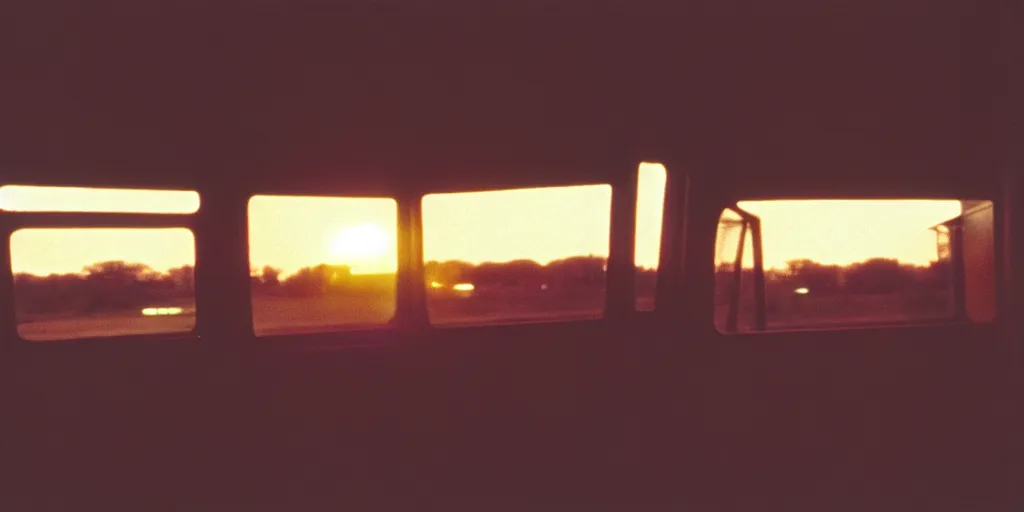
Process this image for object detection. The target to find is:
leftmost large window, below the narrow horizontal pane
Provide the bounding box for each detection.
[10,228,196,341]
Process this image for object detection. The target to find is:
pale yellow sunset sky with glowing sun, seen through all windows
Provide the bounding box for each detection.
[0,164,959,274]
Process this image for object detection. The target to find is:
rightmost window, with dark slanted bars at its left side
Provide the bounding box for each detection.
[715,201,995,332]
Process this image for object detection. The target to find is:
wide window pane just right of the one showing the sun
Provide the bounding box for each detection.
[423,185,611,325]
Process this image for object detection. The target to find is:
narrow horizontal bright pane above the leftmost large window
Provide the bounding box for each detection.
[0,185,199,213]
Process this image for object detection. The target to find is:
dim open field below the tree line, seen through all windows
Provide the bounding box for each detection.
[18,291,951,341]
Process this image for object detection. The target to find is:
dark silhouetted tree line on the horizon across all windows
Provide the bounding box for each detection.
[14,256,937,315]
